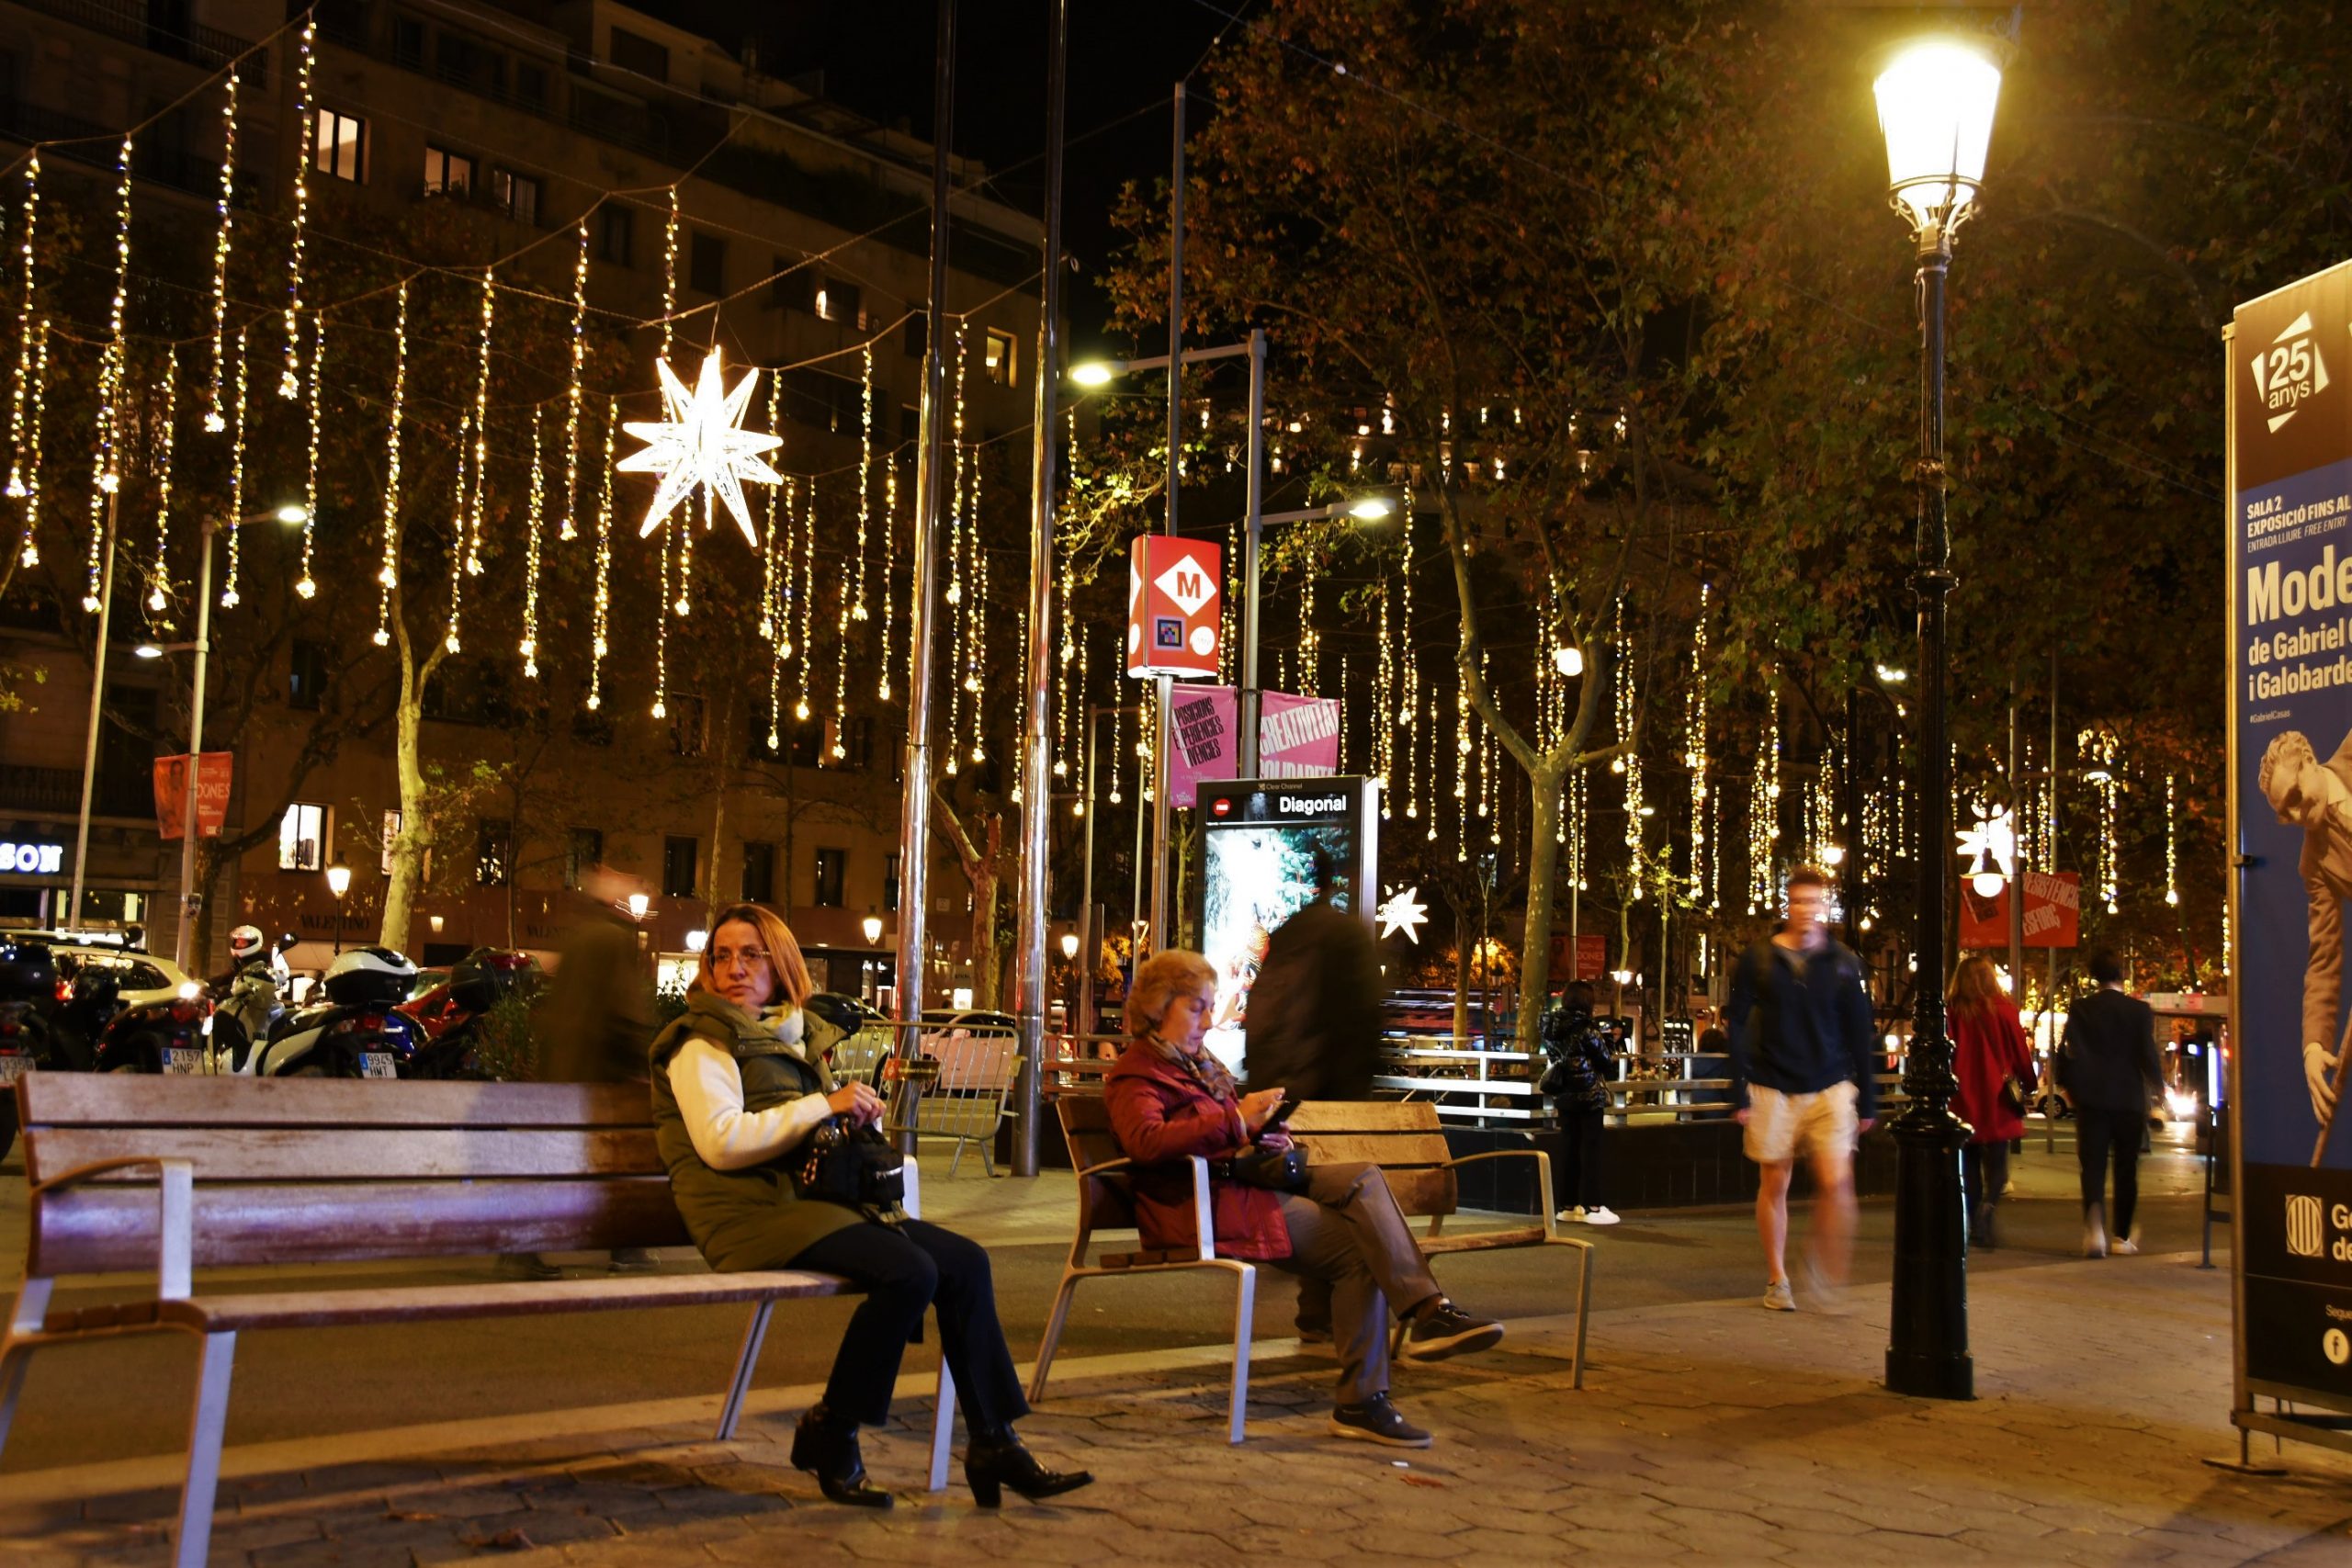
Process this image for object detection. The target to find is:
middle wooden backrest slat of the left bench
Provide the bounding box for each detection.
[24,1126,663,1182]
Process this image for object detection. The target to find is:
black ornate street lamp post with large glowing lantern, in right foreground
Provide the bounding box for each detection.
[1877,38,2002,1399]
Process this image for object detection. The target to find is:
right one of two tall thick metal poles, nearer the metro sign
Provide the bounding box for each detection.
[1012,0,1070,1176]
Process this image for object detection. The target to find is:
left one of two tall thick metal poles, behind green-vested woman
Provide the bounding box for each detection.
[894,0,955,1072]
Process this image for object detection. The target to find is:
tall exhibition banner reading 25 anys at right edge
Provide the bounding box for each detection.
[2227,264,2352,1425]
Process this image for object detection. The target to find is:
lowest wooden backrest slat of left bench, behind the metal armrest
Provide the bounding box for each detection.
[26,1176,689,1277]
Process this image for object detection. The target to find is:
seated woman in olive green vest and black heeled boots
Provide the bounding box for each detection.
[651,905,1093,1506]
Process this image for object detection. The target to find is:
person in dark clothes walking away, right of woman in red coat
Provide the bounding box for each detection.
[2058,952,2164,1258]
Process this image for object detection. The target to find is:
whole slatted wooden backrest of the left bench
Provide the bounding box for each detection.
[17,1072,687,1274]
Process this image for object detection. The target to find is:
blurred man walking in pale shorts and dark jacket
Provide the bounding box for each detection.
[1726,865,1877,1312]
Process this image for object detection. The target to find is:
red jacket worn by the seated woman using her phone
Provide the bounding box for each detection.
[1103,1042,1291,1262]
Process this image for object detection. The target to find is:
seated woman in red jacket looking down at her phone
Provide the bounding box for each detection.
[1103,950,1503,1448]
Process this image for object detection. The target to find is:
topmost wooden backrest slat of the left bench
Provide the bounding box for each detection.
[17,1072,651,1126]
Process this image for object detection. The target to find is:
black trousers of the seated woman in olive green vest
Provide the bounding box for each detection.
[790,1220,1028,1437]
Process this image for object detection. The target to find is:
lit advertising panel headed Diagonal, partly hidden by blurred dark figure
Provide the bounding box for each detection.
[1193,778,1381,1072]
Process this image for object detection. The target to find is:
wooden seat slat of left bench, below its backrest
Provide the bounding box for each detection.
[160,1269,852,1333]
